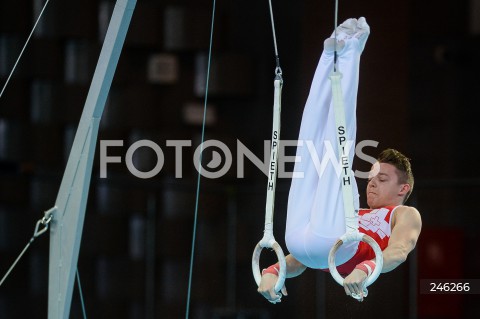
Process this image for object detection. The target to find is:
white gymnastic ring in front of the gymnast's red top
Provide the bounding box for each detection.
[328,232,383,297]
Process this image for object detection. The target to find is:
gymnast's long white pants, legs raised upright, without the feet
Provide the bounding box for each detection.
[285,38,361,268]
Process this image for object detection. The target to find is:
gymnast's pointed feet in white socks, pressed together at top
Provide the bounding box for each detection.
[324,17,370,52]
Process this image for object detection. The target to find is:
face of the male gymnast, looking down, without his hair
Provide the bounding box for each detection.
[367,162,410,209]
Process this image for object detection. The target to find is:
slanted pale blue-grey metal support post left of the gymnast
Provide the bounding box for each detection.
[48,0,136,319]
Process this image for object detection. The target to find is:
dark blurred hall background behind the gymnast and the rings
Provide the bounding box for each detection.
[0,0,480,319]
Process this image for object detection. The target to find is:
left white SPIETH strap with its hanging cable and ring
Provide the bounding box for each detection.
[252,0,287,303]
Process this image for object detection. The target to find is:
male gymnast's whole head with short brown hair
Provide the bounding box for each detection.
[367,148,414,208]
